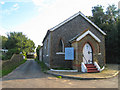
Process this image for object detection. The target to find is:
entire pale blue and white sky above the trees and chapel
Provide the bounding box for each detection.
[0,0,120,46]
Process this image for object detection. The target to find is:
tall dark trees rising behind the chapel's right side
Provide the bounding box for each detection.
[89,5,120,63]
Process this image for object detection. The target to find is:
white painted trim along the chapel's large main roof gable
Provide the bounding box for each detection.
[50,11,106,35]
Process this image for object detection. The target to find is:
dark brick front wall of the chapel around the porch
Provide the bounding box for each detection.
[43,16,105,68]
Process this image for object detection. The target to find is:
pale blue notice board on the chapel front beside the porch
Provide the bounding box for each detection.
[65,47,74,60]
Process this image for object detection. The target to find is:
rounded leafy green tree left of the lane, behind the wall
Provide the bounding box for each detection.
[2,32,35,58]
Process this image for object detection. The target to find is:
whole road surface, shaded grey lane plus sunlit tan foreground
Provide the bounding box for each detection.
[2,60,118,88]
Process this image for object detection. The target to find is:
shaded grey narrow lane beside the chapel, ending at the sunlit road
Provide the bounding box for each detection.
[2,60,45,81]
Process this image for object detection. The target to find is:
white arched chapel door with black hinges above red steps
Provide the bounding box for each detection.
[83,43,93,64]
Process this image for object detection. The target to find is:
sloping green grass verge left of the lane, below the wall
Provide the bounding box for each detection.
[1,59,26,77]
